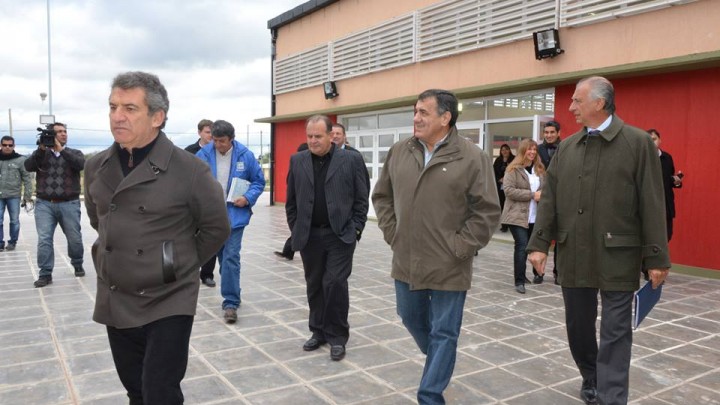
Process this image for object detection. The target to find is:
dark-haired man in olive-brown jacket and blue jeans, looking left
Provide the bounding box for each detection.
[372,90,500,405]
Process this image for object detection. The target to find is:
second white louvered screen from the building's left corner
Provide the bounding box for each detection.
[332,14,413,80]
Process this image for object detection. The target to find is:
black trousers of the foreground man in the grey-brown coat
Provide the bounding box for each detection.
[107,315,193,405]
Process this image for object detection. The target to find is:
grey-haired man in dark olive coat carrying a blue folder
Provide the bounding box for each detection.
[527,77,670,405]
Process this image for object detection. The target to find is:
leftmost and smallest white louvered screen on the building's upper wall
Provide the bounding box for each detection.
[273,45,328,94]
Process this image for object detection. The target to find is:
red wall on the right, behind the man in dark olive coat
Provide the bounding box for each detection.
[555,68,720,270]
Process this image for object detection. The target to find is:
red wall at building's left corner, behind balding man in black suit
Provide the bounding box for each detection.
[273,115,337,202]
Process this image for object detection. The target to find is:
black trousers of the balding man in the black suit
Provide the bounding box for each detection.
[300,228,355,345]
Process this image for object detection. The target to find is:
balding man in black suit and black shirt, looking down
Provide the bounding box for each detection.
[285,115,369,361]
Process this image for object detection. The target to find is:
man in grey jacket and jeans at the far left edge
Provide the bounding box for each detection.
[0,135,32,252]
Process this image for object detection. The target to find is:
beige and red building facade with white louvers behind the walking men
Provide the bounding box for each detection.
[257,0,720,274]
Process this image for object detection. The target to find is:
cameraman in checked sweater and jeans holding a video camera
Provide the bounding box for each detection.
[25,122,85,287]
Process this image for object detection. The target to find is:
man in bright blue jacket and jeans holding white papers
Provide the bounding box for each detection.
[197,120,265,323]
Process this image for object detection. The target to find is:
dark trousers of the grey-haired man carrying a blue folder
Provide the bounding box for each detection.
[562,287,633,405]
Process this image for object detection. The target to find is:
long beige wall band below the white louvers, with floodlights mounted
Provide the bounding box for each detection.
[276,0,720,115]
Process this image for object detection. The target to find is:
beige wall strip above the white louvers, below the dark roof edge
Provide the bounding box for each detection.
[276,0,438,58]
